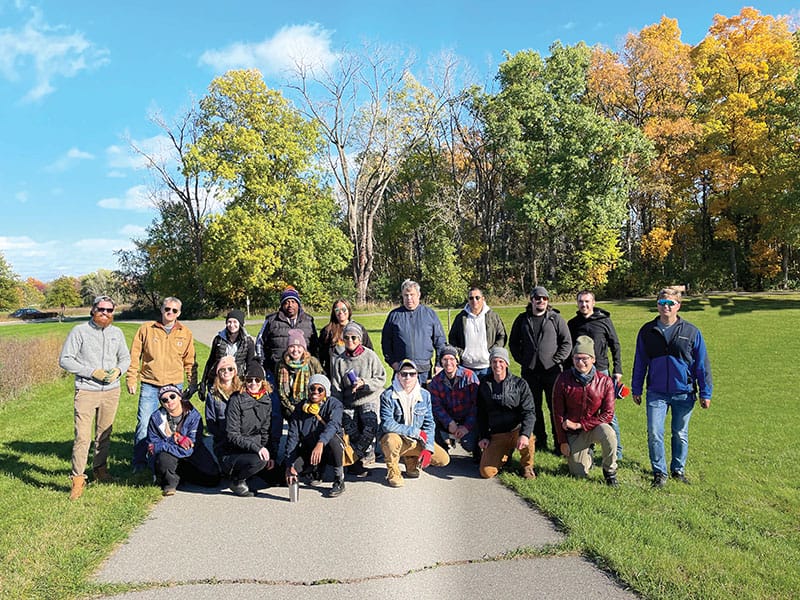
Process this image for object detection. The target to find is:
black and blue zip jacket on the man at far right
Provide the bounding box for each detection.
[631,317,713,400]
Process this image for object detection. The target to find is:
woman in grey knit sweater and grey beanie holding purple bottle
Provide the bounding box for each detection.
[331,322,386,477]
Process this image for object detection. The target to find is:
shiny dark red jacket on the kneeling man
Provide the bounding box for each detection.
[553,368,616,444]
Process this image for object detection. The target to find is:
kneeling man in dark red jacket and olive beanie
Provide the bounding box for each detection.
[553,335,619,487]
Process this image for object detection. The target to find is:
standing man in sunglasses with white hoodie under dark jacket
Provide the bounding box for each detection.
[446,287,506,379]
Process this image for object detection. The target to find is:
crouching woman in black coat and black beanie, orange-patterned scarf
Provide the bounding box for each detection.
[219,361,278,496]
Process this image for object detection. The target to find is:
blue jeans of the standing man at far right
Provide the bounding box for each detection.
[647,391,695,475]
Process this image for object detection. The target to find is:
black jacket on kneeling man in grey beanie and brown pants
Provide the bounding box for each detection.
[478,373,536,440]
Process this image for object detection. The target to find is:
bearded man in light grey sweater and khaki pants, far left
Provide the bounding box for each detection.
[58,296,131,500]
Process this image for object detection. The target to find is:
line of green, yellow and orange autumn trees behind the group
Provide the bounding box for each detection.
[119,8,800,311]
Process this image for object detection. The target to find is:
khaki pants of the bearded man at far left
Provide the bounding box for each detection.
[72,386,120,476]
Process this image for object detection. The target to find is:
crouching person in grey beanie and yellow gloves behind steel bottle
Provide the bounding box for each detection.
[286,374,344,498]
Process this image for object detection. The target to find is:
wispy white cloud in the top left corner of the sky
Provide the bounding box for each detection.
[0,7,109,102]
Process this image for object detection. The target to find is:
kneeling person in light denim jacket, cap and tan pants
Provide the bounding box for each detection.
[381,358,450,487]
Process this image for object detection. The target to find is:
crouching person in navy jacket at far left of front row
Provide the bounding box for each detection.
[147,385,219,496]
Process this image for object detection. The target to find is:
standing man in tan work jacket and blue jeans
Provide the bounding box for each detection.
[126,296,197,473]
